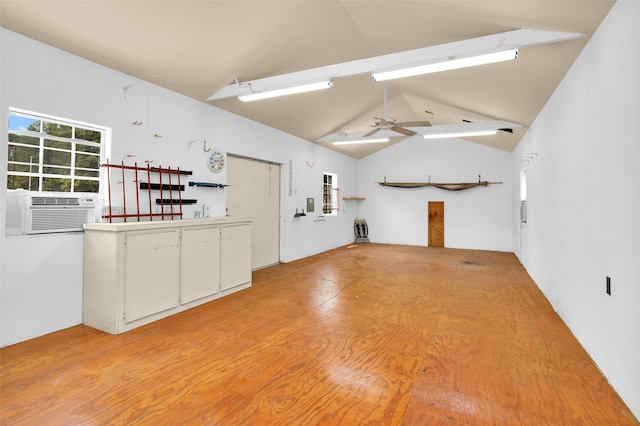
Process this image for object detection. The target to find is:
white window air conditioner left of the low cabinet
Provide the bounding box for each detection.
[6,192,98,235]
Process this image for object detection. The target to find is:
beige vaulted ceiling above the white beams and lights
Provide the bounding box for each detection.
[0,0,613,158]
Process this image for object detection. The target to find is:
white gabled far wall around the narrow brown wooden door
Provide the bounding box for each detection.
[358,136,513,251]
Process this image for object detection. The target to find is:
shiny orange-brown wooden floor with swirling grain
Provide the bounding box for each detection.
[0,244,638,425]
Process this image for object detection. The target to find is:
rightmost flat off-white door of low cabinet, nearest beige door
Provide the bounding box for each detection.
[220,224,251,290]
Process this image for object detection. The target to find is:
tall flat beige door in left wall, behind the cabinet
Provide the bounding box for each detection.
[226,156,280,269]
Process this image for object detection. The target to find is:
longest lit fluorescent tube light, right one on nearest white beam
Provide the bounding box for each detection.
[371,49,518,81]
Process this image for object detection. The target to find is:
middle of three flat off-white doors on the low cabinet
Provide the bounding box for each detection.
[180,226,220,305]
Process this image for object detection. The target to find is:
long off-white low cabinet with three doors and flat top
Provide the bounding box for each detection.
[83,218,251,334]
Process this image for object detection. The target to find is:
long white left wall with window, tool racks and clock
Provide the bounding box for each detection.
[0,29,357,346]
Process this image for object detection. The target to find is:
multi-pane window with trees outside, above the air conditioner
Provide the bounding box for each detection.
[7,109,106,192]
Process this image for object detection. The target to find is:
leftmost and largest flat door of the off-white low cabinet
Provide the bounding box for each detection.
[124,229,180,323]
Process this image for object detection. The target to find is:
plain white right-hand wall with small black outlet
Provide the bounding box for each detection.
[513,1,640,418]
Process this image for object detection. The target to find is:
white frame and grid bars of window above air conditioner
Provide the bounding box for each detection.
[5,107,111,193]
